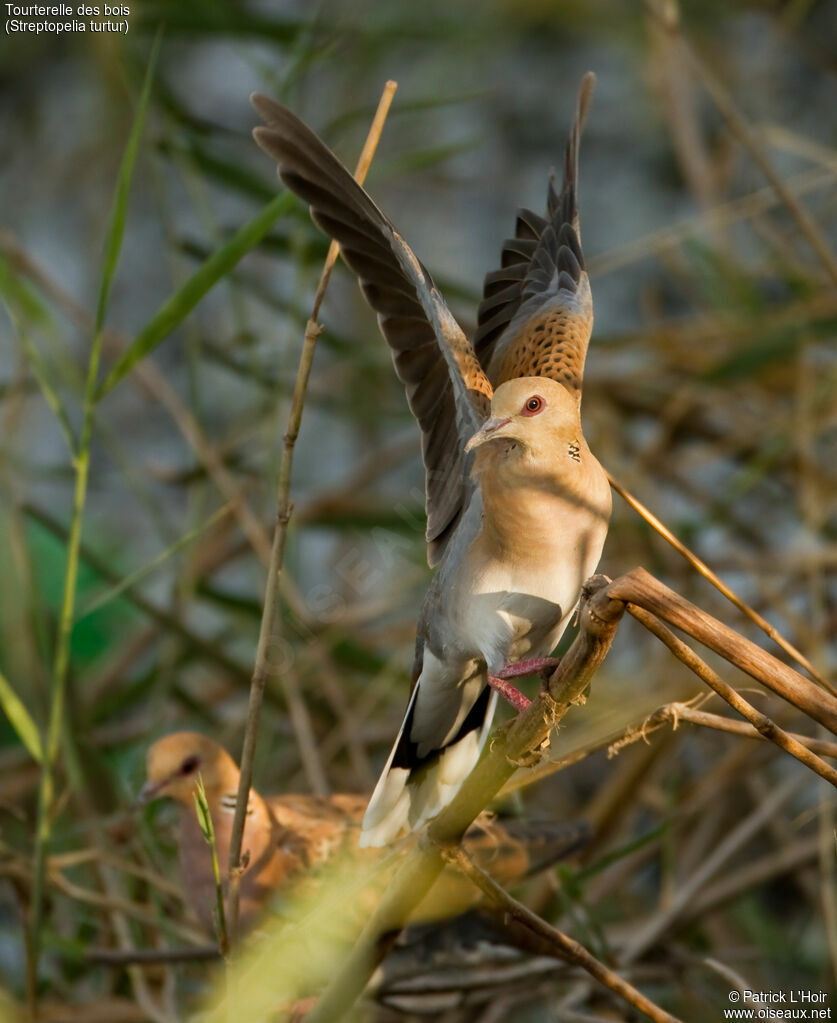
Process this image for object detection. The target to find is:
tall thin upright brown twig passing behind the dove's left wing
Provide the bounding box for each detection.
[228,82,396,941]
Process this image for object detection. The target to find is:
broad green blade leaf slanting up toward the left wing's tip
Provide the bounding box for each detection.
[96,192,294,401]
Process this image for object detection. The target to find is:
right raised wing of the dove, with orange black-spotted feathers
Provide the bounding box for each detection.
[474,72,596,398]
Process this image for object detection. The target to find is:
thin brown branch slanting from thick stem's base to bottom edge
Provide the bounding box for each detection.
[445,848,678,1023]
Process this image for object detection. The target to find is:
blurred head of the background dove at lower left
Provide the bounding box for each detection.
[137,731,238,806]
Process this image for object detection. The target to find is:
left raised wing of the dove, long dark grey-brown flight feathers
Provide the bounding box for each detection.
[252,95,492,565]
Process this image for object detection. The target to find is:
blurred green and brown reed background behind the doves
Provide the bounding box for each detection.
[0,0,837,1021]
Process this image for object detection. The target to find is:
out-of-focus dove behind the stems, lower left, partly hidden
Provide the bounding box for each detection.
[138,731,589,928]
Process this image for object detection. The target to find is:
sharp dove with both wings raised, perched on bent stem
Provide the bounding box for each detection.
[253,74,611,845]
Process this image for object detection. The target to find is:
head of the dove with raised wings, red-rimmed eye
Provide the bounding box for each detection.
[466,376,584,463]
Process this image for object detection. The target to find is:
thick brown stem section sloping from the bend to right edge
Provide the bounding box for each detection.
[608,568,837,735]
